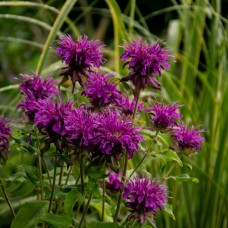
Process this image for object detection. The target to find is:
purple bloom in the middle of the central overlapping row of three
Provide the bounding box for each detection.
[64,107,96,149]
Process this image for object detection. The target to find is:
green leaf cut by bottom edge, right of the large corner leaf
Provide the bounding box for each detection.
[40,214,72,228]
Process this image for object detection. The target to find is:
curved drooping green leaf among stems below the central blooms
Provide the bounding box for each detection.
[64,189,84,216]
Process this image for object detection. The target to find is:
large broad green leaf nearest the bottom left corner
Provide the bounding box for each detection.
[11,201,48,228]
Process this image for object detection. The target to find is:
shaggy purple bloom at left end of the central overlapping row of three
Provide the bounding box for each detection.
[35,100,73,137]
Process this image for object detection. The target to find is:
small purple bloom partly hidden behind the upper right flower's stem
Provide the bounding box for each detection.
[117,97,144,116]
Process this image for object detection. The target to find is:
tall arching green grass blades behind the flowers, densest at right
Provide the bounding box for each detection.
[0,0,228,228]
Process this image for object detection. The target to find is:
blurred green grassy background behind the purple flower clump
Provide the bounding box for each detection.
[0,0,228,228]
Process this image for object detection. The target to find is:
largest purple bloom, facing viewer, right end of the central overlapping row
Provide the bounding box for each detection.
[93,112,143,159]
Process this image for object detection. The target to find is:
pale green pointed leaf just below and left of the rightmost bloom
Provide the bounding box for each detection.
[152,149,183,167]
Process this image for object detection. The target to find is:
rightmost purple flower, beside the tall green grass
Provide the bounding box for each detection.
[171,123,205,154]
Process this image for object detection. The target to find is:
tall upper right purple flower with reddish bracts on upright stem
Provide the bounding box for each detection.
[120,38,172,90]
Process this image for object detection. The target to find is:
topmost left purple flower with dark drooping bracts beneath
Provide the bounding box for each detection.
[56,35,104,90]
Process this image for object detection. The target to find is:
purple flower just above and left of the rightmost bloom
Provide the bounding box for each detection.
[149,103,182,130]
